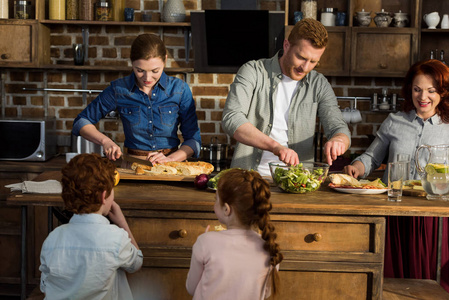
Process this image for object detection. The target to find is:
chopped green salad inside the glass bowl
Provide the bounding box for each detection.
[273,163,324,194]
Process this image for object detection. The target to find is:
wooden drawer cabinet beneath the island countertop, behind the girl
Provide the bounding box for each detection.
[125,210,385,300]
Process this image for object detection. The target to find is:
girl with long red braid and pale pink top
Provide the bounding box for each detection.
[186,169,283,300]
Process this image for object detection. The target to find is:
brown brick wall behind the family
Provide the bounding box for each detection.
[1,0,402,159]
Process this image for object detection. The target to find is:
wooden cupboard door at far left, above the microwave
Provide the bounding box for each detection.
[0,25,32,63]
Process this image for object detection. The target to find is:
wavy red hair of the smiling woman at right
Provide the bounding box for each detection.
[402,59,449,124]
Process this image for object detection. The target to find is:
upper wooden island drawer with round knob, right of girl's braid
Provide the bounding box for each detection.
[272,215,385,262]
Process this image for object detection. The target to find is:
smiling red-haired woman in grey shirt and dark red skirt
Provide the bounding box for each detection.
[345,60,449,291]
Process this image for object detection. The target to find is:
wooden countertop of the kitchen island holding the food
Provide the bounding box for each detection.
[7,171,449,217]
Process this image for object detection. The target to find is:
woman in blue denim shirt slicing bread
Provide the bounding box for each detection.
[72,34,201,163]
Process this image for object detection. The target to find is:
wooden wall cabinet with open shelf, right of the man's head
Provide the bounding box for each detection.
[286,0,419,77]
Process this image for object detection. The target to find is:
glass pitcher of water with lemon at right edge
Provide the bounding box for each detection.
[415,145,449,200]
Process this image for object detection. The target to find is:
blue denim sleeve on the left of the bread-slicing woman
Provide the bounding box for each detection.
[72,86,117,136]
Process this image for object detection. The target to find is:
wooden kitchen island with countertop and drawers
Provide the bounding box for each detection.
[7,171,449,300]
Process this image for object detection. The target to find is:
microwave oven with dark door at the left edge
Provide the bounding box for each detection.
[0,118,56,161]
